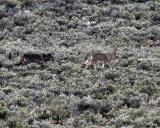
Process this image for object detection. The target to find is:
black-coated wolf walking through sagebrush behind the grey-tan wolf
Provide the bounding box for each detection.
[16,53,54,67]
